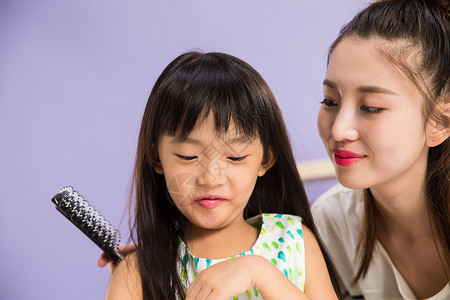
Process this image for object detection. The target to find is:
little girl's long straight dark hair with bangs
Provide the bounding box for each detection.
[133,52,339,299]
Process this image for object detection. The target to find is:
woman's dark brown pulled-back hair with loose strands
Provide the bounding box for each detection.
[328,0,450,282]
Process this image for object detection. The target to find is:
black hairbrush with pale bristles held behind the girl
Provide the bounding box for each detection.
[52,186,123,263]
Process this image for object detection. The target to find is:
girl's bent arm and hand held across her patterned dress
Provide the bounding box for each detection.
[186,226,337,300]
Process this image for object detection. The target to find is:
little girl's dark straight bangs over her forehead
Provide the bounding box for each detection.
[159,59,261,139]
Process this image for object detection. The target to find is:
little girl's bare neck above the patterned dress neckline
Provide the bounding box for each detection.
[186,219,260,259]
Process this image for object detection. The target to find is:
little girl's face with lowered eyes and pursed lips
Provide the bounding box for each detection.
[154,118,267,229]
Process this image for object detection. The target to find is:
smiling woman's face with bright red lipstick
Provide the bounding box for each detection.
[318,37,428,189]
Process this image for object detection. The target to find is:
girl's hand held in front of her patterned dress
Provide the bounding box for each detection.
[186,255,260,300]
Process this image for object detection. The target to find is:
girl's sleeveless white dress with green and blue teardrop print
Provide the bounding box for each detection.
[179,214,305,300]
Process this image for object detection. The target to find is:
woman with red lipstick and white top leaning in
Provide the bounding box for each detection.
[313,0,450,300]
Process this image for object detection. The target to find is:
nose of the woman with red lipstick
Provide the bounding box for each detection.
[331,108,359,142]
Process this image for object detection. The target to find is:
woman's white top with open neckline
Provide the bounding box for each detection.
[312,184,450,300]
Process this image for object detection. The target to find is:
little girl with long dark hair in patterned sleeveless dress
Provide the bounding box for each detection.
[106,52,337,299]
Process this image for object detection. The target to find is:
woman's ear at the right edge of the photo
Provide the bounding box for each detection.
[425,102,450,147]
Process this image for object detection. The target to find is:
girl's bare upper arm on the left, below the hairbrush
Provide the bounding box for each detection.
[105,253,143,300]
